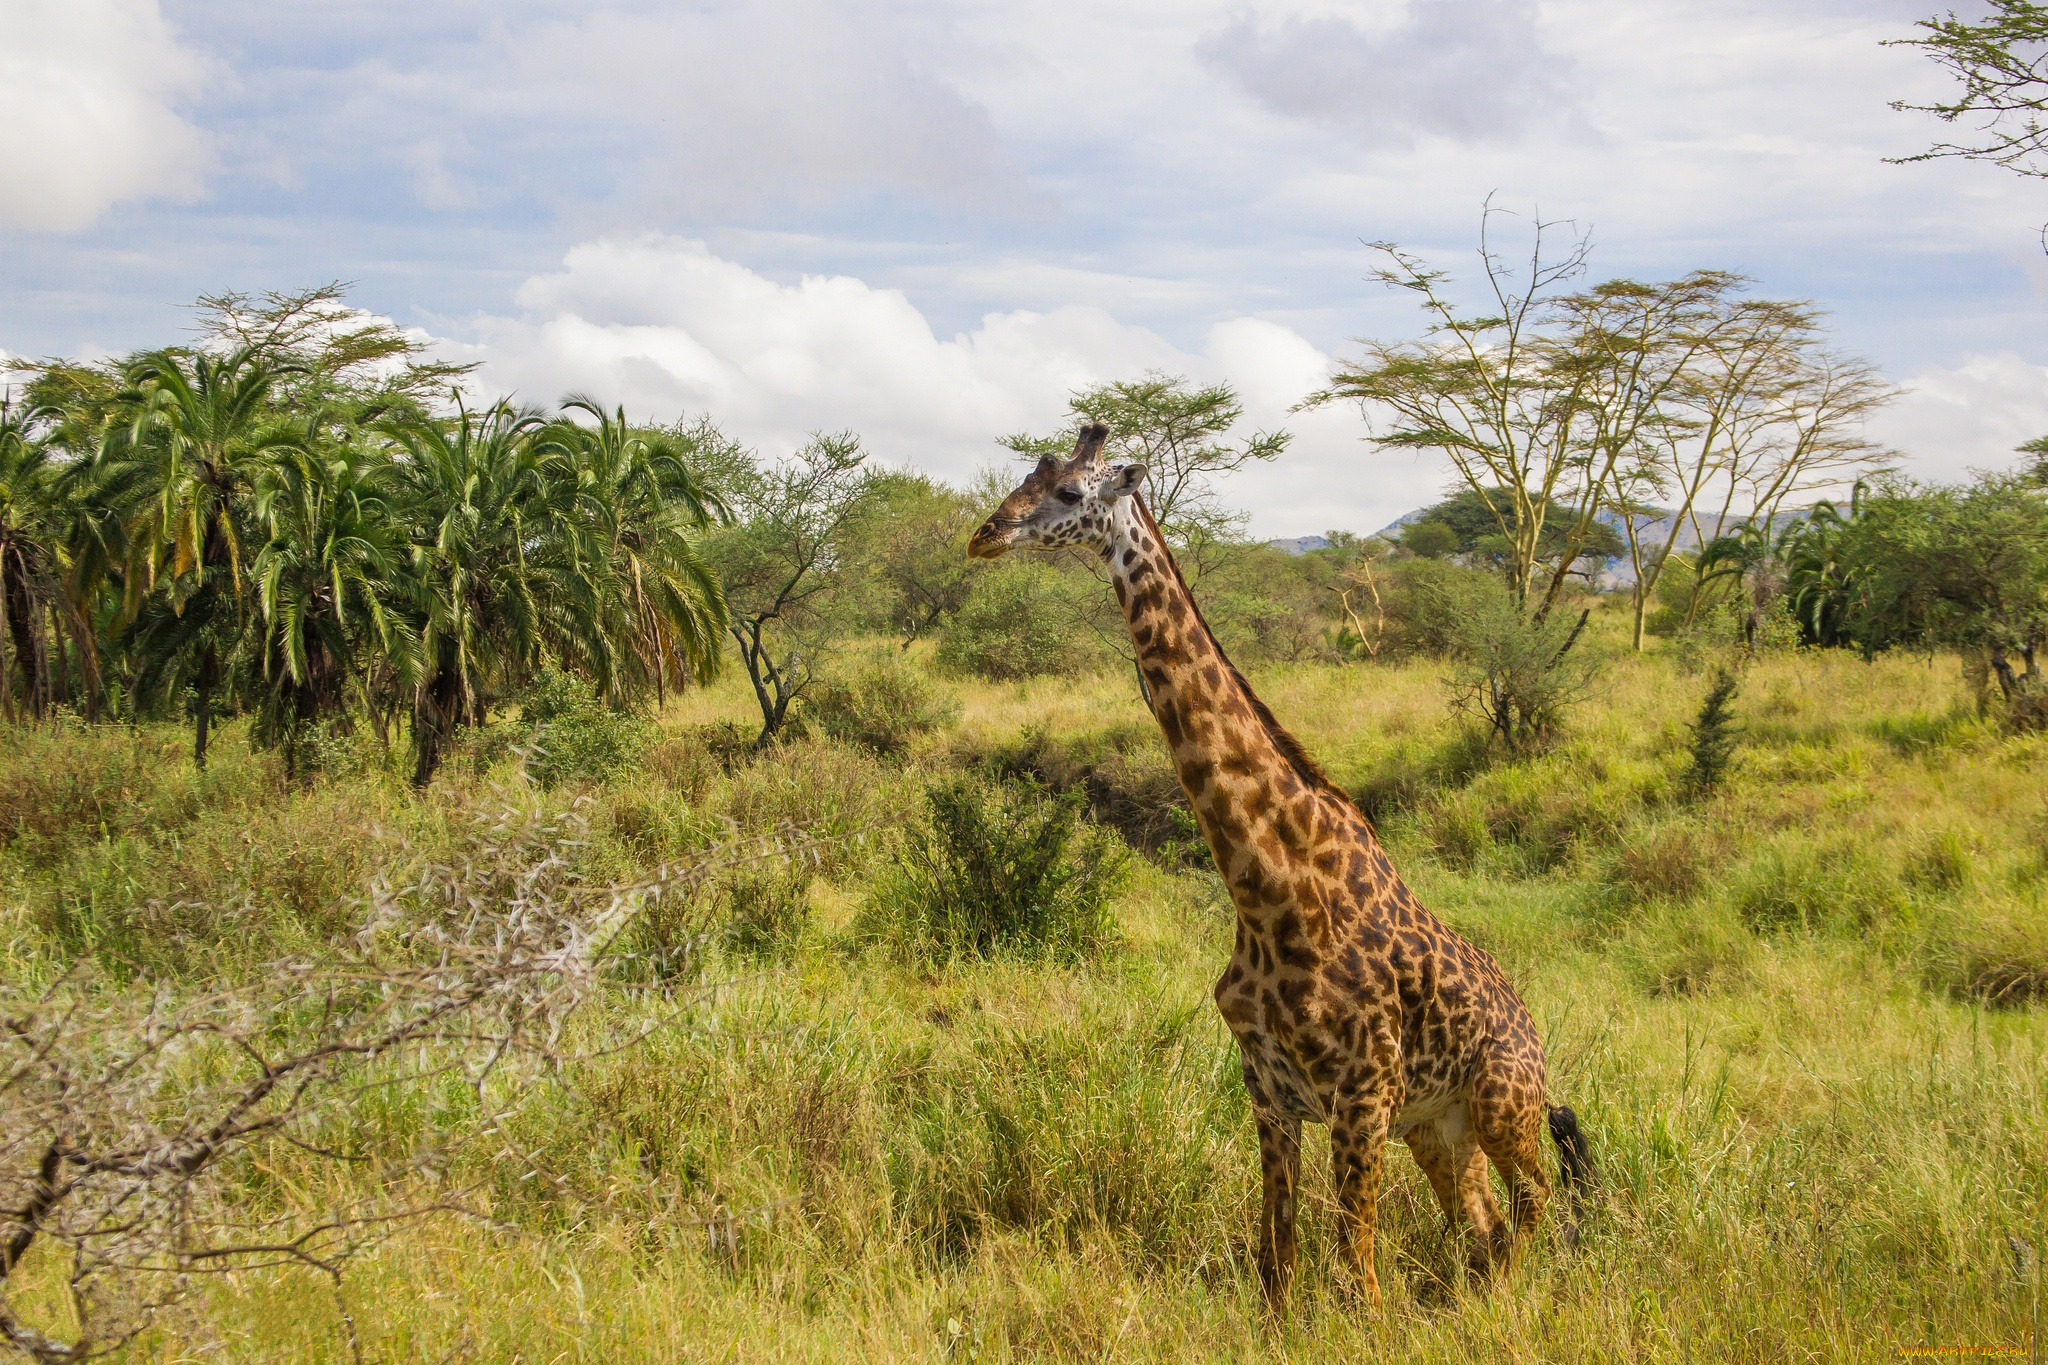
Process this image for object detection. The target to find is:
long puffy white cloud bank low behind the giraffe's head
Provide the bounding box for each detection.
[436,235,1440,534]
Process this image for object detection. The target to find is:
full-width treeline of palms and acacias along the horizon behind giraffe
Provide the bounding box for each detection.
[0,272,2048,786]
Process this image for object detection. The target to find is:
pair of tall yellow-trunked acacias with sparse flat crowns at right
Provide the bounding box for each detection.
[1305,207,1890,649]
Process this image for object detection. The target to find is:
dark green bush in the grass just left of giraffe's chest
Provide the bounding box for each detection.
[870,776,1126,962]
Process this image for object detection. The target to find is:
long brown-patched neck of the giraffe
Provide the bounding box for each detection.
[1108,497,1323,911]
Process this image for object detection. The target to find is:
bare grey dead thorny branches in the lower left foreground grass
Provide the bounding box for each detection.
[0,798,843,1361]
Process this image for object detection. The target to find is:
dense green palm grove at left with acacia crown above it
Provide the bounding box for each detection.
[0,287,729,784]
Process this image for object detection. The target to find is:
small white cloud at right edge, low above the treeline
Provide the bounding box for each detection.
[1870,350,2048,481]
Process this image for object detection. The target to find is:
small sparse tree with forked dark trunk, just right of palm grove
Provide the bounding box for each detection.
[707,432,872,745]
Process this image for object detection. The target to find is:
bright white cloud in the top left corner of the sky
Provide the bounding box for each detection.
[0,0,213,231]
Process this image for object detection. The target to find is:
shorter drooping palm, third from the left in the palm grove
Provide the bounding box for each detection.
[250,431,418,780]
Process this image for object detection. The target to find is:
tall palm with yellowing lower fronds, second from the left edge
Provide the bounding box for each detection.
[102,346,303,767]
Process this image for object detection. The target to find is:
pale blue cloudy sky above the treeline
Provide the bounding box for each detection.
[0,0,2048,536]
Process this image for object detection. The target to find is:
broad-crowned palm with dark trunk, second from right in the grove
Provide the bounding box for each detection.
[385,399,608,786]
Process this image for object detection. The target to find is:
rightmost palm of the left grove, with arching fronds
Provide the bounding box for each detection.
[551,393,731,704]
